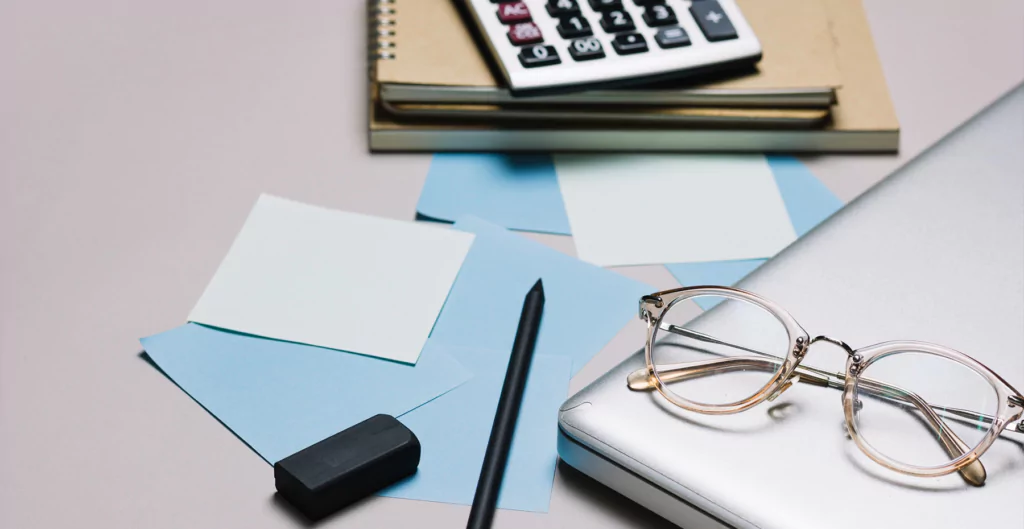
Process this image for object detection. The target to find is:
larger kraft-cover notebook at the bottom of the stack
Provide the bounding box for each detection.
[369,0,899,152]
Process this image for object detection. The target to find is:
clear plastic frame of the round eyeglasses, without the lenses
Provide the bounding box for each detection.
[627,286,1024,486]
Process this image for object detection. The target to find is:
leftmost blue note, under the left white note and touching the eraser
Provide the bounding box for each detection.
[140,323,471,464]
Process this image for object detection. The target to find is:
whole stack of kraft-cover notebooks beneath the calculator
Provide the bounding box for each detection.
[369,0,899,152]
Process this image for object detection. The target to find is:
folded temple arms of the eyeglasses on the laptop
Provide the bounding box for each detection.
[627,325,986,486]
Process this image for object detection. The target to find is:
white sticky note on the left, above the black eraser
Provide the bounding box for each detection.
[188,194,473,363]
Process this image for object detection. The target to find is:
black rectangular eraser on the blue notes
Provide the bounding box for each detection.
[273,414,420,520]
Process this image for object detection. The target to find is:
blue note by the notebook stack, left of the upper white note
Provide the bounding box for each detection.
[416,153,569,235]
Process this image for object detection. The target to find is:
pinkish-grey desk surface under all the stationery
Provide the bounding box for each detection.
[0,0,1024,529]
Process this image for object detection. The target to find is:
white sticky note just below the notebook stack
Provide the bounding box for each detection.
[555,155,797,266]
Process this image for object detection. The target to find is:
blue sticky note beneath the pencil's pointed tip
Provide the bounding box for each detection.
[430,217,653,374]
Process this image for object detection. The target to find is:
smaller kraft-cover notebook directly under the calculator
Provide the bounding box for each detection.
[375,0,840,107]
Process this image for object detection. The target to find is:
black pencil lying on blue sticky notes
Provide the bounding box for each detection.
[466,279,544,529]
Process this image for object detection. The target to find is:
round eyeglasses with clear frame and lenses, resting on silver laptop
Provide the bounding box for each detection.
[627,286,1024,486]
